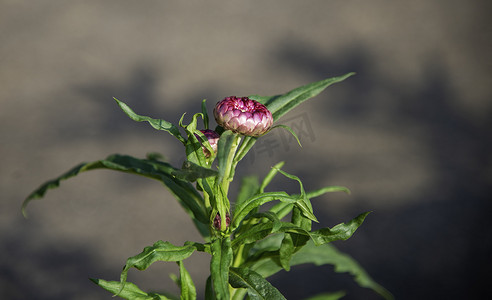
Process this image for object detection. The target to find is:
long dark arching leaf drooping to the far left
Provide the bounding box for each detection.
[22,154,209,237]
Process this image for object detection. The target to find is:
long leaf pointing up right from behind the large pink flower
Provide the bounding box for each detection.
[249,73,355,121]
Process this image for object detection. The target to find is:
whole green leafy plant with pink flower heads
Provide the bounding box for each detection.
[22,73,392,299]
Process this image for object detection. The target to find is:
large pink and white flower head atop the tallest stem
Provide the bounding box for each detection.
[214,96,273,136]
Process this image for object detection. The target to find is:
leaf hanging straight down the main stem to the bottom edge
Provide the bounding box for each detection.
[210,237,233,300]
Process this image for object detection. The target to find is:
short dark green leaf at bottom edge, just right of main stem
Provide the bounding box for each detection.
[229,268,285,300]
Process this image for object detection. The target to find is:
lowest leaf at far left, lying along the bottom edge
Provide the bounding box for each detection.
[90,278,176,300]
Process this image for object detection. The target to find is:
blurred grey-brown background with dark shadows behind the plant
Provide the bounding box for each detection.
[0,0,492,299]
